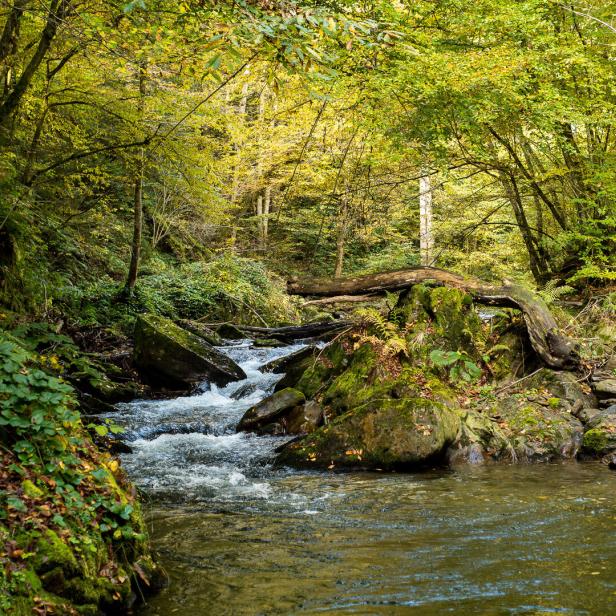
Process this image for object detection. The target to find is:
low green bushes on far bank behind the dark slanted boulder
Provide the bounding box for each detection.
[55,254,298,332]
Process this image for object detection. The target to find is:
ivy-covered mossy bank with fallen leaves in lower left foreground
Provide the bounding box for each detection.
[0,334,157,615]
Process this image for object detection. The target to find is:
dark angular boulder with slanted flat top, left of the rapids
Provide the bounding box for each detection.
[134,314,246,389]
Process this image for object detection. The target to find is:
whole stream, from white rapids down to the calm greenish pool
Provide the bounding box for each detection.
[114,341,616,616]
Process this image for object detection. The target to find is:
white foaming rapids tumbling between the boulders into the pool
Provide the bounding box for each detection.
[109,340,306,502]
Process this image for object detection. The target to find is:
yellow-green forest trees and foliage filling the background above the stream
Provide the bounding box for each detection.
[0,0,616,310]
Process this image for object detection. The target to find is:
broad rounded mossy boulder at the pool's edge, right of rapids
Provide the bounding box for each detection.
[278,398,460,469]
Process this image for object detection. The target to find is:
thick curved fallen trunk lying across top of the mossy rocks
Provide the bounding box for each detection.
[287,267,579,368]
